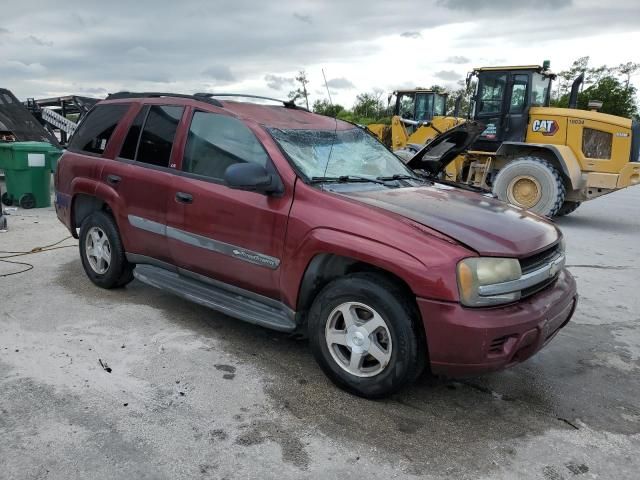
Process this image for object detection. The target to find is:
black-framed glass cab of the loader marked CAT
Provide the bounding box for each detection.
[467,62,555,152]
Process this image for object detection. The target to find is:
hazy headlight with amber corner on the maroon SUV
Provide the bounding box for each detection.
[458,257,522,307]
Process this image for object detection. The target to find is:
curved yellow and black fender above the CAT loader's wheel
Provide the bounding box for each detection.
[496,142,583,190]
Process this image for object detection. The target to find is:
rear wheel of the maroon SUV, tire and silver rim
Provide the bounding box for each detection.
[79,211,133,289]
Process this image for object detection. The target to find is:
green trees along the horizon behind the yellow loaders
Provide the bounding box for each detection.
[289,56,640,125]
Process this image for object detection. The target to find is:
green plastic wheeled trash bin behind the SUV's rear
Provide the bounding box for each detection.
[0,142,62,208]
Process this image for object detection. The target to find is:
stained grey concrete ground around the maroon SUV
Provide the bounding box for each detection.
[0,187,640,480]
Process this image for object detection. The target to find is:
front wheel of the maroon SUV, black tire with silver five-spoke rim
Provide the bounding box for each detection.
[309,273,426,398]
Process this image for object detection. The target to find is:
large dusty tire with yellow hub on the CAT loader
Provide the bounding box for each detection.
[493,156,566,217]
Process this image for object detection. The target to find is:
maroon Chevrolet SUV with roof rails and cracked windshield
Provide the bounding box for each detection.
[56,93,577,397]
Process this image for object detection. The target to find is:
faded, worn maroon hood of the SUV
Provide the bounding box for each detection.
[342,183,560,258]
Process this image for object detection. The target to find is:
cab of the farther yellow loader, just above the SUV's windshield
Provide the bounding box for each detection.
[389,89,447,134]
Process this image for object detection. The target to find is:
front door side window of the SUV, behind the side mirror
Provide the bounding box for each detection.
[182,112,268,179]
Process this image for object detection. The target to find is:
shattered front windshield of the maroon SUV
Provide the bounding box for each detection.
[269,128,415,179]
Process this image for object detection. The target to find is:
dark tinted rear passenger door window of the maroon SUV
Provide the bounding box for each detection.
[136,105,184,167]
